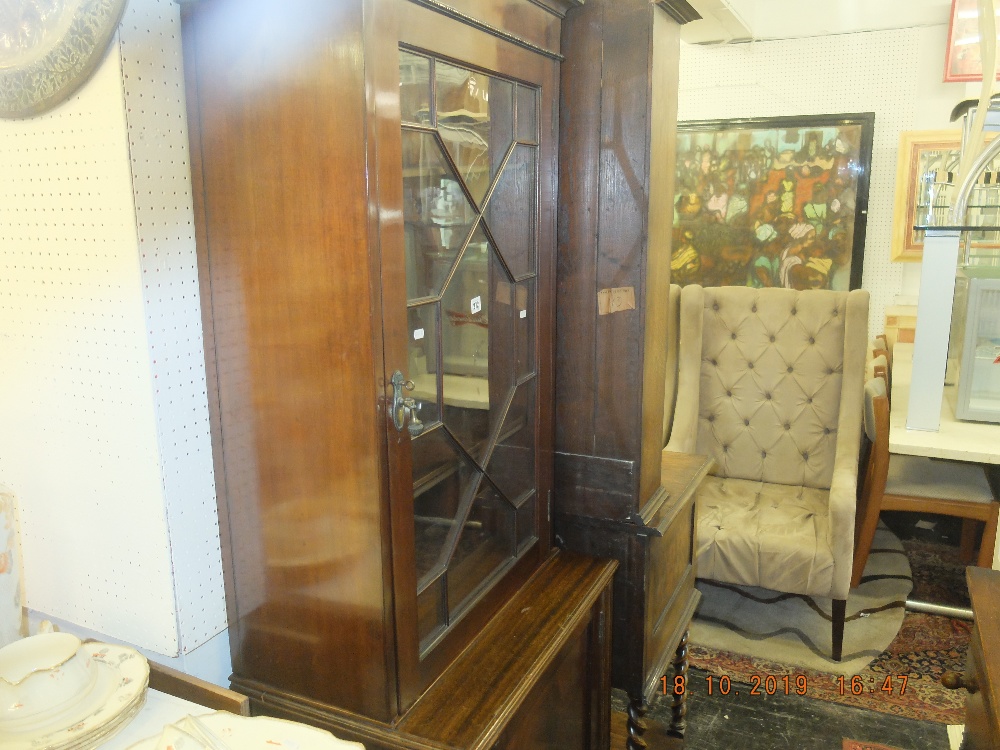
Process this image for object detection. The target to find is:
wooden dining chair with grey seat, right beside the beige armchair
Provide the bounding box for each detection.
[851,377,1000,588]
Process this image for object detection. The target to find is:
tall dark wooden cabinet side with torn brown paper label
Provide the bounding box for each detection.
[556,0,679,520]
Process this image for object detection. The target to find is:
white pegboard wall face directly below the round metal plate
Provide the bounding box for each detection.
[0,39,177,653]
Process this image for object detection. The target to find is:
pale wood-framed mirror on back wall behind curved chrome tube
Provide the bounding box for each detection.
[890,130,1000,261]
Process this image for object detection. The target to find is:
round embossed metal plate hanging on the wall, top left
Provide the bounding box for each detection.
[0,0,126,118]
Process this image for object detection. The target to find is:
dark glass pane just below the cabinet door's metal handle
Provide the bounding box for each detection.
[413,429,481,588]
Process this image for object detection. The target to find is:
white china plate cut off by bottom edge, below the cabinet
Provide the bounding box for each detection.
[128,711,365,750]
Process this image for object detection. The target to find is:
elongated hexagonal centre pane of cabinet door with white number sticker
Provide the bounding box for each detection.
[441,238,515,465]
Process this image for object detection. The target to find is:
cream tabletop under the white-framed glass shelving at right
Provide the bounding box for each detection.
[889,342,1000,464]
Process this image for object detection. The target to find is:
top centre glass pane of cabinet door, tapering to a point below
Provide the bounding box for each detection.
[435,62,514,204]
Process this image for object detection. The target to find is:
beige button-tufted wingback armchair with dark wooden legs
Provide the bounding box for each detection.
[667,285,868,661]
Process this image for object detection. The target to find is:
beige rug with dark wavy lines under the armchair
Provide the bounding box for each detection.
[691,525,912,676]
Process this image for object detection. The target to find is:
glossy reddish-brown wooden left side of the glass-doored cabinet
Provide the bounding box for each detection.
[183,0,395,718]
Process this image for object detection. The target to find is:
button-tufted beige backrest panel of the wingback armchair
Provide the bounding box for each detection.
[698,287,847,489]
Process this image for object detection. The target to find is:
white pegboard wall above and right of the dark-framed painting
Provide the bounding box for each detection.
[678,27,928,338]
